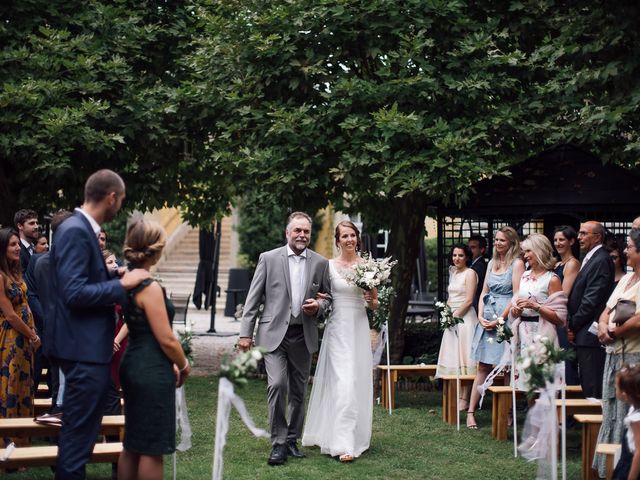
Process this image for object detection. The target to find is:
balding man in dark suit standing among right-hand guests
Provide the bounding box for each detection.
[567,221,615,398]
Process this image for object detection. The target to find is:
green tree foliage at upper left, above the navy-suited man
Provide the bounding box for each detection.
[0,1,218,225]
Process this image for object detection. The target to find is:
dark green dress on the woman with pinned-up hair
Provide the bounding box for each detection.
[120,279,176,456]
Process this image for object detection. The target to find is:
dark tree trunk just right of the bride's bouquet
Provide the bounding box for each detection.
[388,193,427,363]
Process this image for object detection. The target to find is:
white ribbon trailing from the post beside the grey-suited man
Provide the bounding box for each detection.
[212,378,270,480]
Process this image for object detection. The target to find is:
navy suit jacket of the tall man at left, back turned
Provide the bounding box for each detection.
[43,212,126,363]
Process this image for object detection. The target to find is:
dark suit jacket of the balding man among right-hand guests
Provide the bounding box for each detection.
[567,247,615,347]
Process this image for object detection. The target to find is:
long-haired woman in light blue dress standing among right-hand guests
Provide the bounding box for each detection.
[467,227,524,430]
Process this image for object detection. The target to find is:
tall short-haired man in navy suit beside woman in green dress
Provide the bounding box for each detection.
[45,170,150,480]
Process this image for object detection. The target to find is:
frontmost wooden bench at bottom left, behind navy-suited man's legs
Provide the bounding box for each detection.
[0,442,122,468]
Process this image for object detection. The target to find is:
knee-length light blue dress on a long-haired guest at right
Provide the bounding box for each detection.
[471,261,515,365]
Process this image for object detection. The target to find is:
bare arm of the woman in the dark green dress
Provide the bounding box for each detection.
[135,282,190,386]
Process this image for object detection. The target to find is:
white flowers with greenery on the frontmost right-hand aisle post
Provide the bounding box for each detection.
[519,335,573,397]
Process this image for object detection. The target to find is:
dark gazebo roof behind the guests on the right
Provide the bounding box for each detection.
[439,145,640,218]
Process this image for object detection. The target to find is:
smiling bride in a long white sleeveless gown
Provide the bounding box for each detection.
[302,221,378,462]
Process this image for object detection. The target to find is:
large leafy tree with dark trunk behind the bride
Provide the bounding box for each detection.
[188,0,638,360]
